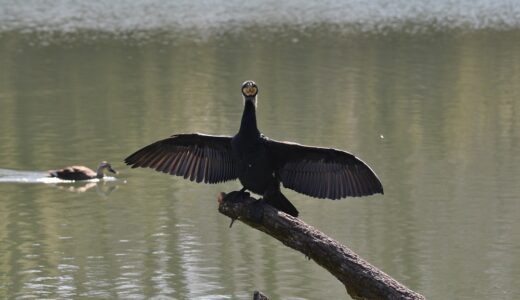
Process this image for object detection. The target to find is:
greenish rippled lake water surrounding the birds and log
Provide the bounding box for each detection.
[0,0,520,299]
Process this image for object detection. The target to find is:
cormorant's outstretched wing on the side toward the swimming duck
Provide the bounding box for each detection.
[125,133,238,183]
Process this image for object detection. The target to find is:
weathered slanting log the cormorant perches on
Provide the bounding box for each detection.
[218,192,425,299]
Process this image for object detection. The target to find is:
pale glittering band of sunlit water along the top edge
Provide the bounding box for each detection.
[0,0,520,38]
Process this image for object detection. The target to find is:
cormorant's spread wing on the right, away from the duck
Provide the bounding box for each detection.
[265,139,383,199]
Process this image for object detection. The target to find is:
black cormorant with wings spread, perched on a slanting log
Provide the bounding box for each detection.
[125,81,383,217]
